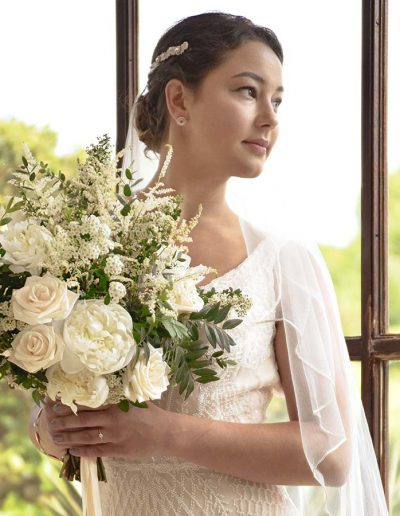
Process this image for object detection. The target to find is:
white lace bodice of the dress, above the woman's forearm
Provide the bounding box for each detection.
[156,232,282,423]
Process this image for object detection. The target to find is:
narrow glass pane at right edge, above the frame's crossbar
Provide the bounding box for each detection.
[387,1,400,333]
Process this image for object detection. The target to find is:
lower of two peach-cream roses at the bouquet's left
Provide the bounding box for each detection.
[2,324,64,373]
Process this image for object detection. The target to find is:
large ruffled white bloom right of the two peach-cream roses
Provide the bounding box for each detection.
[61,299,136,375]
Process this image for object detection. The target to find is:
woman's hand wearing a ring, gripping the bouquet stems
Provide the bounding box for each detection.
[44,400,174,459]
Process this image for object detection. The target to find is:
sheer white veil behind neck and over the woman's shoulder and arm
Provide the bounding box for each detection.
[122,102,388,516]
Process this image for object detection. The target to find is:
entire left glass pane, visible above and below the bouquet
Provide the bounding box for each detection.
[0,0,116,516]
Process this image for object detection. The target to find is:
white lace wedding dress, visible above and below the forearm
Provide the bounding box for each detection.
[100,230,297,516]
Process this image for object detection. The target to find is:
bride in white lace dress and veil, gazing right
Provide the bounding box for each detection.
[31,12,387,516]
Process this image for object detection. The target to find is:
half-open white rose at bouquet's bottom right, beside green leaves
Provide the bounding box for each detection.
[123,344,170,403]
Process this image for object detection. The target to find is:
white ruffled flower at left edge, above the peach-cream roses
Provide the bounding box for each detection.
[0,214,53,275]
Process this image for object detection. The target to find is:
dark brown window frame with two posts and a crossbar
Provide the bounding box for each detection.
[116,0,400,505]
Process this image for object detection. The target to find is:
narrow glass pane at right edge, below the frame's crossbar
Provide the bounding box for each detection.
[389,360,400,516]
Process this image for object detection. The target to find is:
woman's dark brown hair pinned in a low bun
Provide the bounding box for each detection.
[134,11,283,156]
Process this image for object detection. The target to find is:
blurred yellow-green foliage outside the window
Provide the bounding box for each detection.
[0,119,400,516]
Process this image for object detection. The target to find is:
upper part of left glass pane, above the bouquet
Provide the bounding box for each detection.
[0,0,116,202]
